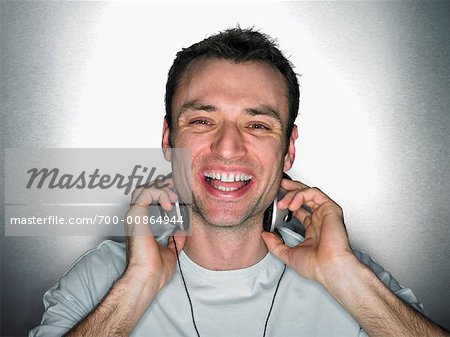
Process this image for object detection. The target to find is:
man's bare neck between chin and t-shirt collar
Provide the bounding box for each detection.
[184,218,268,270]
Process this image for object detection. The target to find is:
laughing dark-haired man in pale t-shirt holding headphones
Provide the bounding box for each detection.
[30,28,447,337]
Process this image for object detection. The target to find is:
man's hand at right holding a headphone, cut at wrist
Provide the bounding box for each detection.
[262,179,357,284]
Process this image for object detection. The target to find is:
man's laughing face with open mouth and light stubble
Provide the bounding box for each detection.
[163,59,297,226]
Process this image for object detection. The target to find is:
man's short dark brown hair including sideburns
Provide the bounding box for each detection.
[165,27,300,141]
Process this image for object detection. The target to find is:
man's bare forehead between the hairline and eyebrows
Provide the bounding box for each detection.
[172,58,288,118]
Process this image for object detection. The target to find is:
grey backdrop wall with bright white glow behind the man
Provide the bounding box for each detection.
[0,2,450,336]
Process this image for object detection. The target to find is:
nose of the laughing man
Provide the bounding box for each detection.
[211,124,246,160]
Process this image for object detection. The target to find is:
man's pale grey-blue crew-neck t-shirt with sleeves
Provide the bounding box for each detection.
[29,233,421,337]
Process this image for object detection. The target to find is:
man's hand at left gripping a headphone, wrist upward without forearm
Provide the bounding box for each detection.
[125,178,186,292]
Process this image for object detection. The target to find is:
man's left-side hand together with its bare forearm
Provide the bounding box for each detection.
[65,179,186,337]
